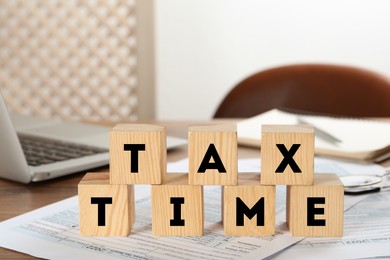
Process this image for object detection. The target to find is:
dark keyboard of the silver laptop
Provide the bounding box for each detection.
[18,135,108,166]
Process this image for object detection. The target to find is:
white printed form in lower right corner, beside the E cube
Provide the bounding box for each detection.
[272,191,390,259]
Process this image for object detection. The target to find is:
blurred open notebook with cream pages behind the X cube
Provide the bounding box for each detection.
[237,109,390,161]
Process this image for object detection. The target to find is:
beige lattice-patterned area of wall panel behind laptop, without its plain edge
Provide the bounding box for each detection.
[0,0,138,121]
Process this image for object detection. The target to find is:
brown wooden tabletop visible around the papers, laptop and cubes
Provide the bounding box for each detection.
[0,120,390,259]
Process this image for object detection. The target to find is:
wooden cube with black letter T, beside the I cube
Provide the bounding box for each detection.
[78,173,135,236]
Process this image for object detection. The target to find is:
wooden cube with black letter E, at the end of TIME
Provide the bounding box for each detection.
[286,174,344,237]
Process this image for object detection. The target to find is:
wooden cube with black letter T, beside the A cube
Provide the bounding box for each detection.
[110,124,167,184]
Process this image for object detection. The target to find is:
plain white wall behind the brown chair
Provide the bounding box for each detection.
[155,0,390,119]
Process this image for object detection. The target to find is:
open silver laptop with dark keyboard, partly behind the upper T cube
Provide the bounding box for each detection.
[0,94,187,183]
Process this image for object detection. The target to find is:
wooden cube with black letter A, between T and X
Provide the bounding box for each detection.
[188,125,238,185]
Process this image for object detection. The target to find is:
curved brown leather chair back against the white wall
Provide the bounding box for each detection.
[214,64,390,118]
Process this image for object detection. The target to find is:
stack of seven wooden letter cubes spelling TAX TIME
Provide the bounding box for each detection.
[79,124,344,236]
